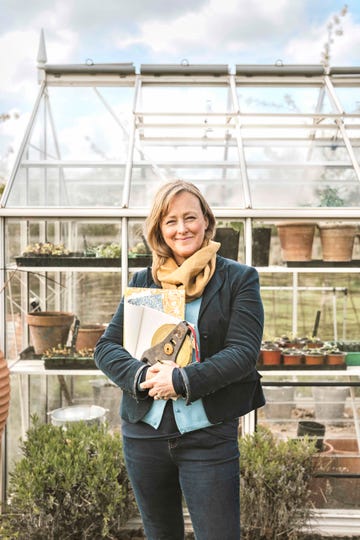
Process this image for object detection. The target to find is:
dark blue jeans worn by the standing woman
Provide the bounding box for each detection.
[123,430,240,540]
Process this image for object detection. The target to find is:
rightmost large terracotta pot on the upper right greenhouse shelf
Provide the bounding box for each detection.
[319,224,357,262]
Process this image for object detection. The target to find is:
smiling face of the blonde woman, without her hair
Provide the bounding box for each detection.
[160,191,208,264]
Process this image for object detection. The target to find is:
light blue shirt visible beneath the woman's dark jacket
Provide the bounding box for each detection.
[142,298,213,433]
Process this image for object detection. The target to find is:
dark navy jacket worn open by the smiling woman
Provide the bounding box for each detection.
[95,255,265,423]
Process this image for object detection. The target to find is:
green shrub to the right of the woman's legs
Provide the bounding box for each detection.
[239,427,316,540]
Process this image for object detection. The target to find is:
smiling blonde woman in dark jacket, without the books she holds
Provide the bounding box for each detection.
[95,180,264,540]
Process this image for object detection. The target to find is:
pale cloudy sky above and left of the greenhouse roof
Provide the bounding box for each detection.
[0,0,360,182]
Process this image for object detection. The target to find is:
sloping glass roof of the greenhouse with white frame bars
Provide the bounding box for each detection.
[2,39,360,215]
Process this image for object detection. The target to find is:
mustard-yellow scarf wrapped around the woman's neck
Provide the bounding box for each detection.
[157,241,220,302]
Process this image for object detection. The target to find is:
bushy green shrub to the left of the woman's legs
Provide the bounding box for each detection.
[0,418,135,540]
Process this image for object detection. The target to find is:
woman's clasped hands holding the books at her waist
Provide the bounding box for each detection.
[140,361,178,399]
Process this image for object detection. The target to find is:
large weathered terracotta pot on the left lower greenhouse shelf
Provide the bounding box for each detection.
[26,311,74,354]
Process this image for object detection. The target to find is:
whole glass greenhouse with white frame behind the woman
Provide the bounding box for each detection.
[0,33,360,534]
